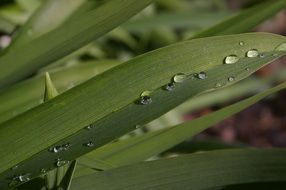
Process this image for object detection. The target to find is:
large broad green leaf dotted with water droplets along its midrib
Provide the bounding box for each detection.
[0,33,286,188]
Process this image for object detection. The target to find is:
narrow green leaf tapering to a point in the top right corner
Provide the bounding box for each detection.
[192,0,286,38]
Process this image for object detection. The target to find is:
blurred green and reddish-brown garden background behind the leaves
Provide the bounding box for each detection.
[0,0,286,152]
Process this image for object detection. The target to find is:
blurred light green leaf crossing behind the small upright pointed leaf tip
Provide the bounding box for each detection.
[0,60,119,123]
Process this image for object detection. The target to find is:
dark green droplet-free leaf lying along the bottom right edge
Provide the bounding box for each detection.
[71,149,286,190]
